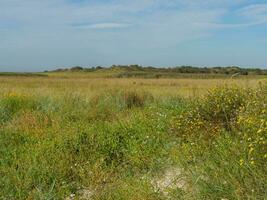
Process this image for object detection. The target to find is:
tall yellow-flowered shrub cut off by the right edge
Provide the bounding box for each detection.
[236,84,267,169]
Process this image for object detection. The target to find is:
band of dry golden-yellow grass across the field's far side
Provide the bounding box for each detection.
[0,76,266,97]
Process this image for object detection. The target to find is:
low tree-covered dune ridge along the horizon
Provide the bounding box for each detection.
[46,65,267,79]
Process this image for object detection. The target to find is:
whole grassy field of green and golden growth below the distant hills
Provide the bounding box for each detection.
[0,72,267,200]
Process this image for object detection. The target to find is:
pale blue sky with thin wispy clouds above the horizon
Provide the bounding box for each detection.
[0,0,267,71]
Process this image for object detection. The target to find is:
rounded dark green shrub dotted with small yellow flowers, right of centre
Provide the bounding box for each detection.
[172,87,249,140]
